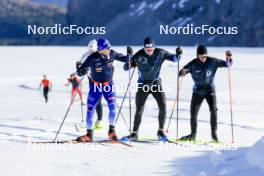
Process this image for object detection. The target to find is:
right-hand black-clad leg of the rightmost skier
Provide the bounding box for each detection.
[206,93,218,141]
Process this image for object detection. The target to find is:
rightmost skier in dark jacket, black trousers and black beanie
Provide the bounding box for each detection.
[179,45,232,142]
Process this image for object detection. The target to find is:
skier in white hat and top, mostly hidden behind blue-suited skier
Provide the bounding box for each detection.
[76,39,103,129]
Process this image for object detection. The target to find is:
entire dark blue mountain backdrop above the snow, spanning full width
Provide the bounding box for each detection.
[0,0,264,47]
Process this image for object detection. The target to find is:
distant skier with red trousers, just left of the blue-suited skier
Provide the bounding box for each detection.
[65,73,84,105]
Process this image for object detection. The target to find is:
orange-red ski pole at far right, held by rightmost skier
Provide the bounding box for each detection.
[226,51,235,143]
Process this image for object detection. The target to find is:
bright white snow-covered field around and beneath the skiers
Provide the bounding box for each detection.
[0,47,264,176]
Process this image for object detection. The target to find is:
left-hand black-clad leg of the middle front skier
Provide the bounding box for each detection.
[133,87,149,133]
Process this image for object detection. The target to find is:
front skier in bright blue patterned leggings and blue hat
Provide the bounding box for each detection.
[77,39,127,142]
